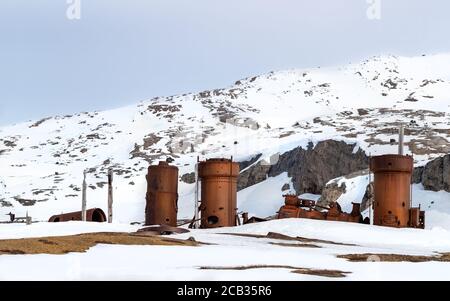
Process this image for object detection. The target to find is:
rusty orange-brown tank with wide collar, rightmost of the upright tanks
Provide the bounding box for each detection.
[370,155,413,227]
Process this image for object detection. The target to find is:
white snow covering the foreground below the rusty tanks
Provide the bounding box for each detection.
[0,219,450,281]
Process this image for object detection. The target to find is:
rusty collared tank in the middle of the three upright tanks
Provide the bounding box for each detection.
[198,159,239,228]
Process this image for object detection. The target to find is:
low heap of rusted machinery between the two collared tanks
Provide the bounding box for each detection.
[278,195,362,223]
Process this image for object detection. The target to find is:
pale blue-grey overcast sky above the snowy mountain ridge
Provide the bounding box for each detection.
[0,0,450,124]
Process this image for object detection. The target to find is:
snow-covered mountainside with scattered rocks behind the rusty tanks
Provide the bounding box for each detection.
[0,54,450,228]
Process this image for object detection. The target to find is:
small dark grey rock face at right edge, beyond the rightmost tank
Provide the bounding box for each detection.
[421,155,450,192]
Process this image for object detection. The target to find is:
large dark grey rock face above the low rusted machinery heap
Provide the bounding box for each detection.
[238,140,368,194]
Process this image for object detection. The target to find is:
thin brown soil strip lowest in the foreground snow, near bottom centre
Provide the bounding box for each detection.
[200,265,350,278]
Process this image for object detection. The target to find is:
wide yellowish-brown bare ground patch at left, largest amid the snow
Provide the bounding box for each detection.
[0,233,199,255]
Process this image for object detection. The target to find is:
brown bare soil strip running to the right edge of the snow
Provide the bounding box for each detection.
[337,253,450,262]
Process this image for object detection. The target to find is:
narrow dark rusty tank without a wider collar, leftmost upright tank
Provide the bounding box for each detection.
[145,161,178,227]
